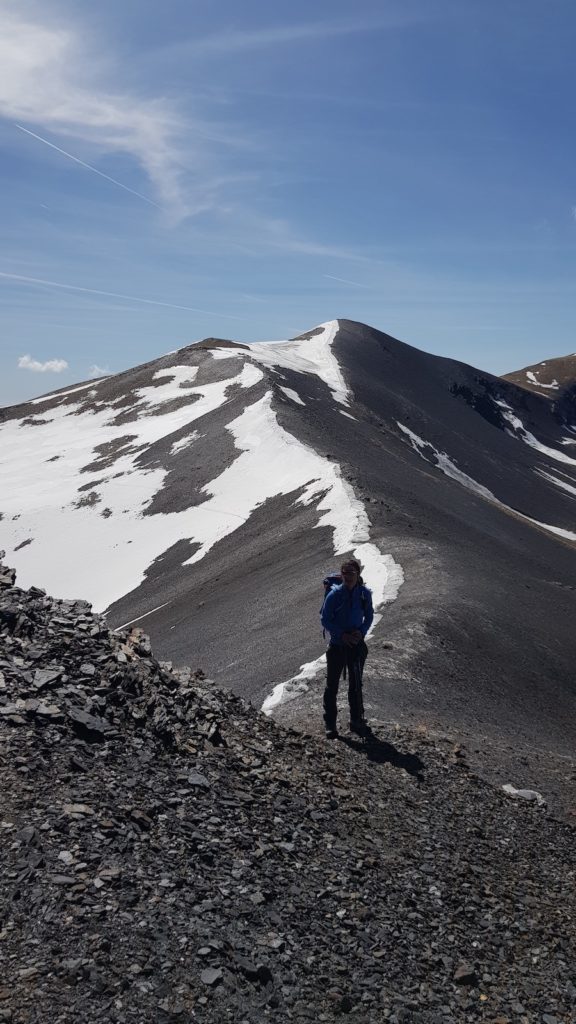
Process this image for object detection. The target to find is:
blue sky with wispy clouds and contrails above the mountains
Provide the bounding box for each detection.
[0,0,576,404]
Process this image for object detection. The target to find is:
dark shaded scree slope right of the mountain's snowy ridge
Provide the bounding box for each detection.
[287,322,576,788]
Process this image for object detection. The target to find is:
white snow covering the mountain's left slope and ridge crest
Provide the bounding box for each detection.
[0,322,403,702]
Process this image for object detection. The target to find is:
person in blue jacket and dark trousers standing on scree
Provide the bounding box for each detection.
[321,558,374,739]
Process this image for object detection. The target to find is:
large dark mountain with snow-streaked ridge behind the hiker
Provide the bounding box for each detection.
[0,321,576,787]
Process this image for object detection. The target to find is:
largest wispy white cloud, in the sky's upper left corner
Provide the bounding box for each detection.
[0,2,195,219]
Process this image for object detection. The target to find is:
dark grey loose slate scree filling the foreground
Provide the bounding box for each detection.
[0,566,576,1024]
